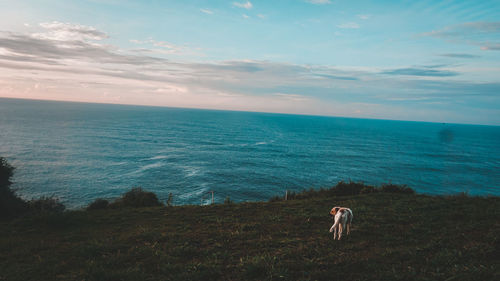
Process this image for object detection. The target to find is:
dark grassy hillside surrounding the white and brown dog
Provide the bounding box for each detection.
[0,193,500,281]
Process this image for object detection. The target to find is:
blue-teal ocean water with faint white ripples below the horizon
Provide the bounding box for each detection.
[0,99,500,208]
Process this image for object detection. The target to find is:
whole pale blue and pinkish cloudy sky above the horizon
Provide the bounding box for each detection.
[0,0,500,125]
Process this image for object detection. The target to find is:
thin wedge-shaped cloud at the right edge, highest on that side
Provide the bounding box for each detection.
[419,22,500,51]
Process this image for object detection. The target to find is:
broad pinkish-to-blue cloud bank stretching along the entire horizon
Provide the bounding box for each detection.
[0,23,500,123]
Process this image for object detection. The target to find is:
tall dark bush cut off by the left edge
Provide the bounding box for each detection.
[0,157,27,217]
